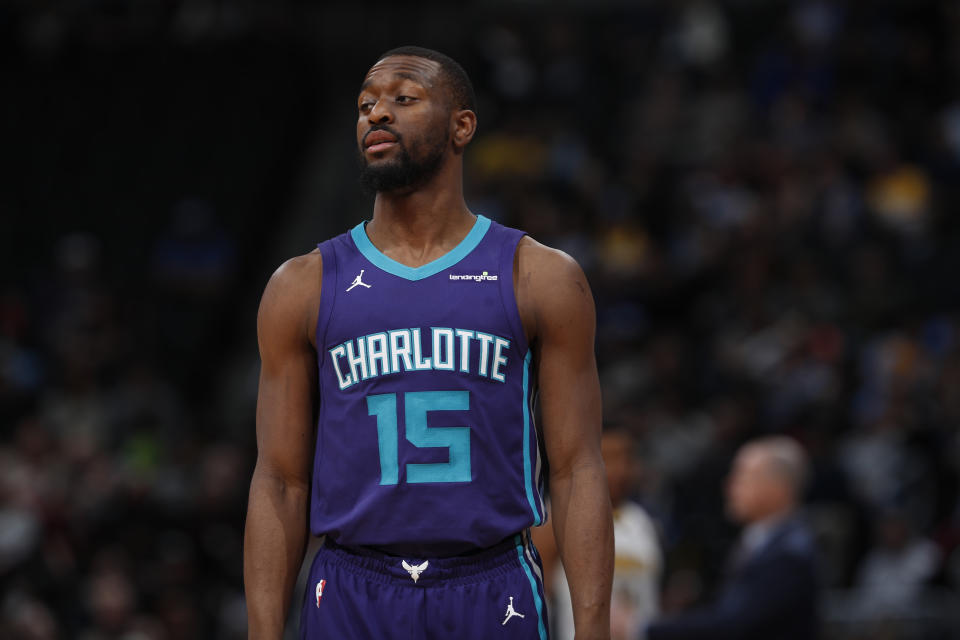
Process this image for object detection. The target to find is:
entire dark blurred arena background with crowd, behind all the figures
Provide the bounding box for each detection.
[0,0,960,639]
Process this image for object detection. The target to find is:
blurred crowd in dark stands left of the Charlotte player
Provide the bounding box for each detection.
[0,218,251,639]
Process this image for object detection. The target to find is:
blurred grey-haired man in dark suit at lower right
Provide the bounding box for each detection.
[644,437,818,640]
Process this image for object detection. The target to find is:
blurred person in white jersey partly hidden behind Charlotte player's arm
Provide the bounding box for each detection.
[533,428,663,640]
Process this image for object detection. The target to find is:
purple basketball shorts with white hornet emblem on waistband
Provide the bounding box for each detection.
[300,531,548,640]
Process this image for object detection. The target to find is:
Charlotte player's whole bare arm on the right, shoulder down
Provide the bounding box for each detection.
[517,238,613,640]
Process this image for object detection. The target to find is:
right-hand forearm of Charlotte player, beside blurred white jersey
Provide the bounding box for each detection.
[550,461,613,640]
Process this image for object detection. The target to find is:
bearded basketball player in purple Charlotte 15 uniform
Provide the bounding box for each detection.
[244,47,613,640]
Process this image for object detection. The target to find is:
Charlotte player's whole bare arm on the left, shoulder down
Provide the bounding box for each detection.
[243,252,321,640]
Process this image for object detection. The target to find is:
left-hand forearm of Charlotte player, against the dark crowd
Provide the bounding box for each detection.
[243,467,307,640]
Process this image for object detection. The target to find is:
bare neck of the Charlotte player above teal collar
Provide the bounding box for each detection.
[367,162,476,267]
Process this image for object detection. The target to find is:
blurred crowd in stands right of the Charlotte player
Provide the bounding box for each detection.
[472,2,960,637]
